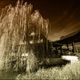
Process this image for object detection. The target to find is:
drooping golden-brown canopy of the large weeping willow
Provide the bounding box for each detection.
[0,1,48,72]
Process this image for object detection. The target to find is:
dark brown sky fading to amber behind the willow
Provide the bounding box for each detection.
[0,0,80,40]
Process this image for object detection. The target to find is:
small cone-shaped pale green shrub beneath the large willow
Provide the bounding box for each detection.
[26,50,38,73]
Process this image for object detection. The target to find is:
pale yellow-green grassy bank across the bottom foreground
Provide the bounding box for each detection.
[16,62,80,80]
